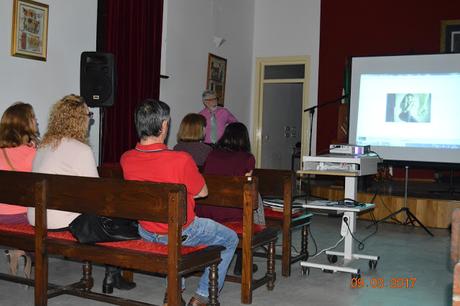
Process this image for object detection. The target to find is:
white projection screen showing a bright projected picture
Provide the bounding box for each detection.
[349,53,460,164]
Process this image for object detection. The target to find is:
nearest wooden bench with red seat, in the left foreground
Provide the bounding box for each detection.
[0,171,223,305]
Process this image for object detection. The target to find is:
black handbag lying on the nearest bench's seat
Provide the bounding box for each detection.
[69,214,140,243]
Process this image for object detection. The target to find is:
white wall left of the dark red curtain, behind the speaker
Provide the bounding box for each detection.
[0,0,99,158]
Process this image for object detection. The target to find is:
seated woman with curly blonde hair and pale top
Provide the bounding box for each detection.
[27,94,136,293]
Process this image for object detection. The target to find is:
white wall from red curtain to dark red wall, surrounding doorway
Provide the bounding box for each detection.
[160,0,320,152]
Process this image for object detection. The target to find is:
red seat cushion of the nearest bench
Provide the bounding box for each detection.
[0,224,206,256]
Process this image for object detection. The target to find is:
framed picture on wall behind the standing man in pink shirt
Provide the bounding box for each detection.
[206,53,227,106]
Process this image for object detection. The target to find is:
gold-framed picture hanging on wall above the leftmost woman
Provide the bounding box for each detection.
[11,0,48,61]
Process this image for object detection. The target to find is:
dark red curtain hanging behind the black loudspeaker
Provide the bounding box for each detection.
[99,0,163,163]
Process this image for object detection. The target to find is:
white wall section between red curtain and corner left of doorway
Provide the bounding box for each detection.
[160,0,254,146]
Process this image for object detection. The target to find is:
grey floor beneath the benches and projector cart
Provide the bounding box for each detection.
[0,216,452,306]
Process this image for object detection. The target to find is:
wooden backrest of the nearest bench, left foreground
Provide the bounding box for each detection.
[0,171,186,224]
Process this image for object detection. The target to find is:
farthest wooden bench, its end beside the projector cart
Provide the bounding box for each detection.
[253,169,312,277]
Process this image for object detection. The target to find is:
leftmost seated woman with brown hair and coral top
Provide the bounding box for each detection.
[0,102,39,223]
